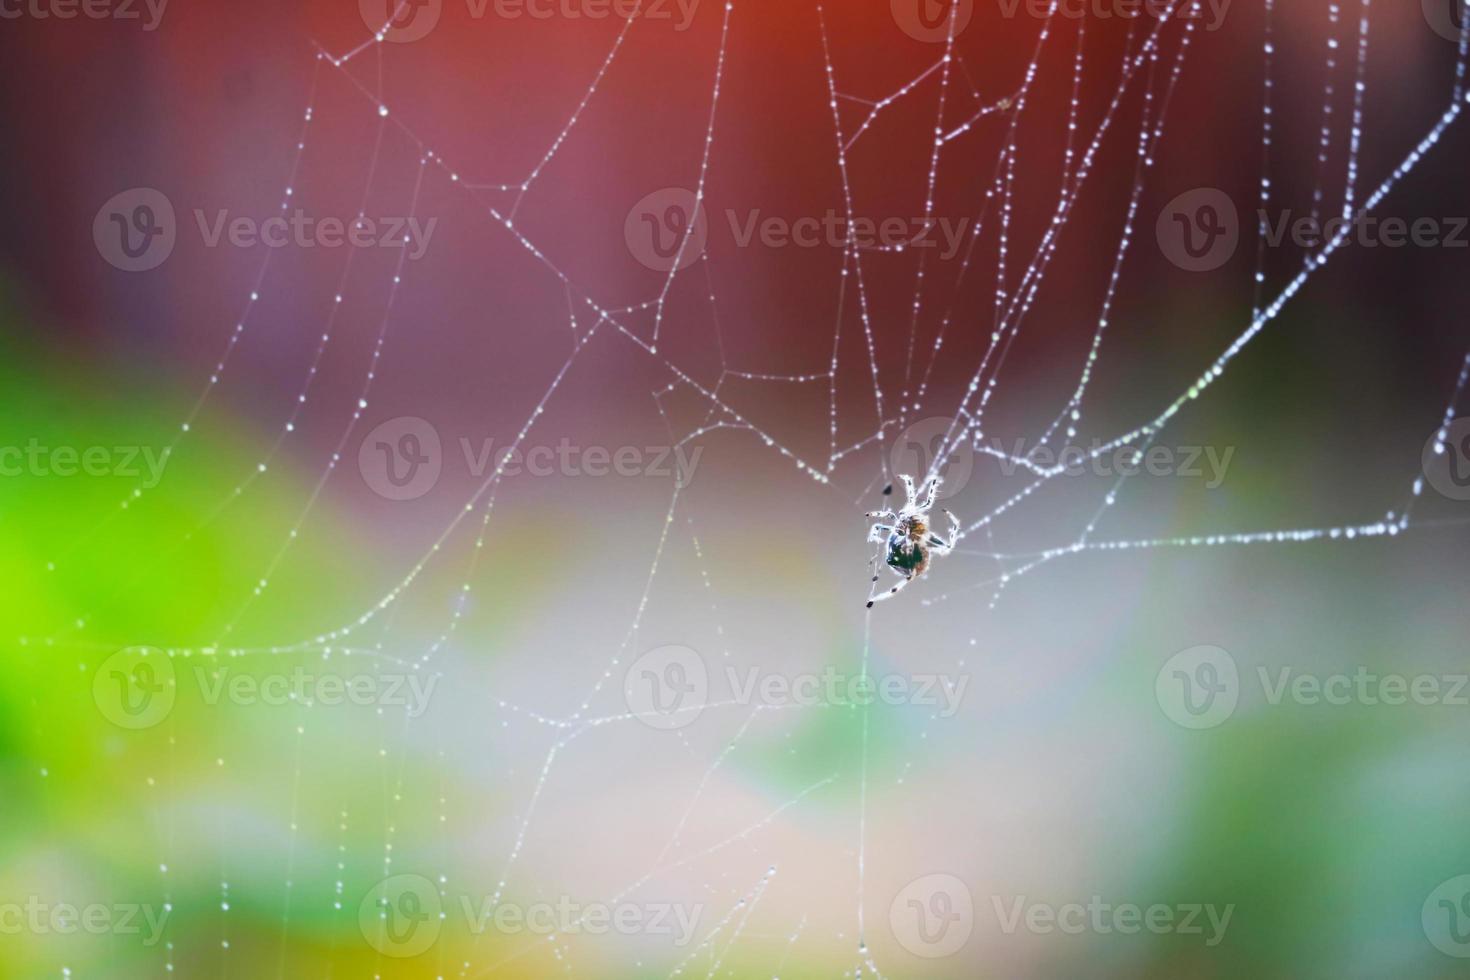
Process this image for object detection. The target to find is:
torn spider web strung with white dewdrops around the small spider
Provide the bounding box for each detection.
[24,0,1470,977]
